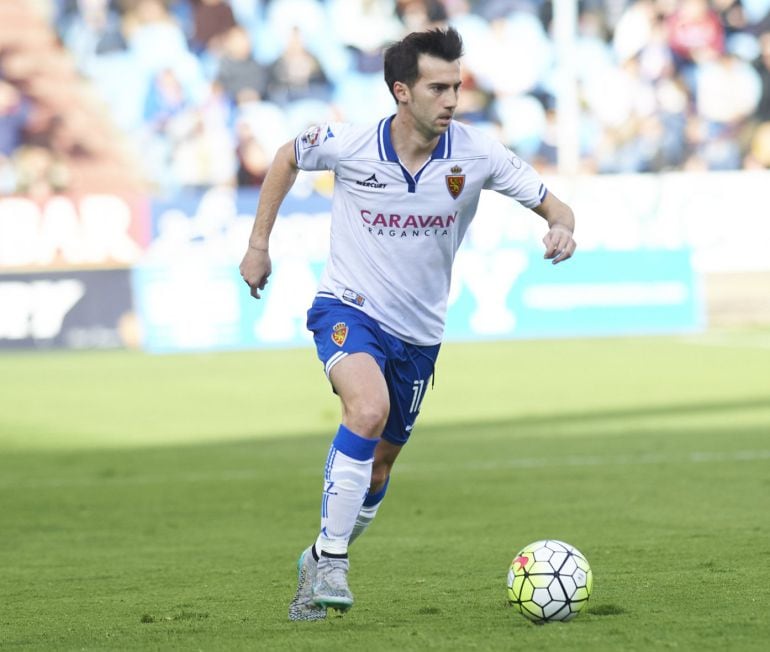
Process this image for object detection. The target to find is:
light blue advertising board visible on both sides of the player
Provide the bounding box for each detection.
[133,249,704,352]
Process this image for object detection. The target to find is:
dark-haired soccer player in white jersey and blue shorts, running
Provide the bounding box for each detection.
[240,28,575,620]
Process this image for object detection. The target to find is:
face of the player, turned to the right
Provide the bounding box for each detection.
[404,54,461,139]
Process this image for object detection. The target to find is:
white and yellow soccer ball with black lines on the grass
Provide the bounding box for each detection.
[508,539,594,623]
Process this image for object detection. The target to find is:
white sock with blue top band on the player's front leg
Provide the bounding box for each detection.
[315,425,378,556]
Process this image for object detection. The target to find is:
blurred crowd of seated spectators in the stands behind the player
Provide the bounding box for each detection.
[0,0,770,194]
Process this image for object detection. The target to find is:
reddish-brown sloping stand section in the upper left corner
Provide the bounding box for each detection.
[0,2,143,198]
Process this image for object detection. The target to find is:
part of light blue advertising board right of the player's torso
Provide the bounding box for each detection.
[446,249,705,340]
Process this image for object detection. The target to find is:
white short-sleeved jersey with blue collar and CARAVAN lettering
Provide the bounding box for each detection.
[294,116,547,345]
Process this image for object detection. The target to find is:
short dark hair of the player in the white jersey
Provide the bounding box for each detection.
[385,27,463,101]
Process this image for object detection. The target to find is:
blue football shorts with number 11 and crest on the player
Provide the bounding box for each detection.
[307,296,441,446]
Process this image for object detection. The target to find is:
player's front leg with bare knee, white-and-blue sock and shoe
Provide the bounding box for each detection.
[312,353,390,611]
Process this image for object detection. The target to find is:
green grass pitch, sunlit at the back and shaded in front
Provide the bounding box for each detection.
[0,332,770,652]
